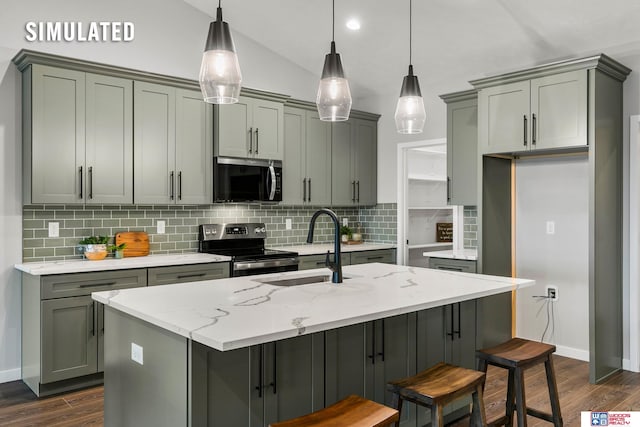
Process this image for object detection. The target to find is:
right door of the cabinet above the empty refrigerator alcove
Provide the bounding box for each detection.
[531,70,587,149]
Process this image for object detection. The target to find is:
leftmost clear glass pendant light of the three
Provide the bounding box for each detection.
[199,0,242,104]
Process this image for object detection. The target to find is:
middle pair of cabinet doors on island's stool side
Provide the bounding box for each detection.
[325,313,416,426]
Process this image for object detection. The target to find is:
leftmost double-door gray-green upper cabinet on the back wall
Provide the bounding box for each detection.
[23,64,133,204]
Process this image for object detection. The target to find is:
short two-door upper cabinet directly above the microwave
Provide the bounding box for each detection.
[215,96,284,160]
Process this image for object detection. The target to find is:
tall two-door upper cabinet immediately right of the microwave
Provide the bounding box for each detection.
[282,107,331,205]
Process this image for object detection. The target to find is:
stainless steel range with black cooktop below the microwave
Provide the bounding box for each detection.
[198,223,298,277]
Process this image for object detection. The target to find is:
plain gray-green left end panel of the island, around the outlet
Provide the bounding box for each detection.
[104,306,188,427]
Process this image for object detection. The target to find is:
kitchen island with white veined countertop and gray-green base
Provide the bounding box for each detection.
[93,264,534,426]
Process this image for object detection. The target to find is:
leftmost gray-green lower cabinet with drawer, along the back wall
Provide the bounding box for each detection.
[22,269,147,396]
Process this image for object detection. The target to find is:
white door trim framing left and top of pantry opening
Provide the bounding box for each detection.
[396,138,447,265]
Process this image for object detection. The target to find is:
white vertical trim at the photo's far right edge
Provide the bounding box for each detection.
[623,115,640,372]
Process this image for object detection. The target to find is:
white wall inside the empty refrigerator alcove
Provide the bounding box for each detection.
[515,156,589,360]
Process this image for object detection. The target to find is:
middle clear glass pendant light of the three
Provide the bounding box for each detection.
[316,0,351,122]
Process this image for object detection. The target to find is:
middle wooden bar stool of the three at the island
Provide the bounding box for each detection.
[387,363,486,427]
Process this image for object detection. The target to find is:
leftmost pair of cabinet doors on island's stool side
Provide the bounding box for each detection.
[192,333,324,427]
